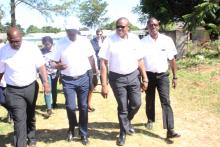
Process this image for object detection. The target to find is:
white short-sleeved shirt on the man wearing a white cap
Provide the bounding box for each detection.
[54,35,95,77]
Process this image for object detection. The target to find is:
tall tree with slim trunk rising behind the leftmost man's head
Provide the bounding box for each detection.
[10,0,77,26]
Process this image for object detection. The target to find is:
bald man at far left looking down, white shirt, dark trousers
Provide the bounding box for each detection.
[0,27,50,147]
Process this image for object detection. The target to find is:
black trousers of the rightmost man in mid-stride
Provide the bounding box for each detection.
[146,72,174,129]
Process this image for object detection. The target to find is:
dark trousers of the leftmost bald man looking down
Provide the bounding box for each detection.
[5,81,39,147]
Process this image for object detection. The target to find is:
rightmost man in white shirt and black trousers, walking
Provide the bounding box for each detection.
[141,17,180,138]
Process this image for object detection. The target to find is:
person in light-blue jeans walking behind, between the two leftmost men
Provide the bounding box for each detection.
[41,36,58,116]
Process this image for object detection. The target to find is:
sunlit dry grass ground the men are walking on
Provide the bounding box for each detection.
[0,63,220,147]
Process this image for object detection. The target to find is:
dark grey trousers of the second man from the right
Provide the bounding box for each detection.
[109,70,141,133]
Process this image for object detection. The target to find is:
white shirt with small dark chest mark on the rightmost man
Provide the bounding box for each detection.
[141,33,177,73]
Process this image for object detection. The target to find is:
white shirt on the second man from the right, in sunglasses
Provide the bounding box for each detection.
[98,33,143,74]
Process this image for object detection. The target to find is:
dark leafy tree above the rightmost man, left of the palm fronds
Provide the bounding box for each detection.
[135,0,199,24]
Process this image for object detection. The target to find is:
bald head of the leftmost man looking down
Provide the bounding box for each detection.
[7,27,22,50]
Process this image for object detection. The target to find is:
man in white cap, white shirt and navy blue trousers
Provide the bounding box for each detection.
[54,18,96,145]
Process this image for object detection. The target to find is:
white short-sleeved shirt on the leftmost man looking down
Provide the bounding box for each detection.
[0,41,45,87]
